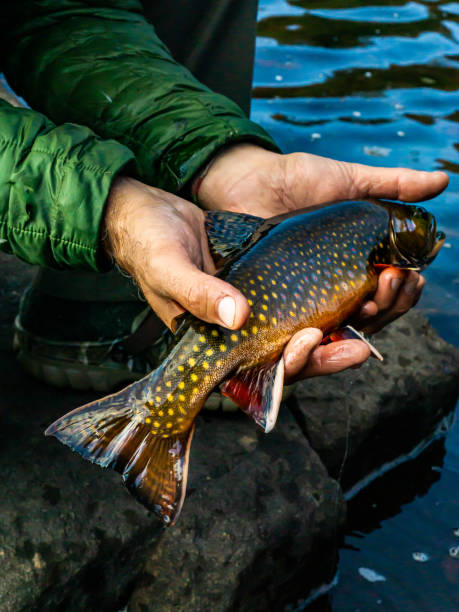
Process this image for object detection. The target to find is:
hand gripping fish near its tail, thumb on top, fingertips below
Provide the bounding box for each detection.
[105,177,378,381]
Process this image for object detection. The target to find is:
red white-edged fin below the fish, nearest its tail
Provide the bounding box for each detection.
[221,356,284,433]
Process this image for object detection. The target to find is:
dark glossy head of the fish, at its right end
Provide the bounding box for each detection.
[378,202,445,271]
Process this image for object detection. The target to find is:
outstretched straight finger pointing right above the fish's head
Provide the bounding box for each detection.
[346,164,449,202]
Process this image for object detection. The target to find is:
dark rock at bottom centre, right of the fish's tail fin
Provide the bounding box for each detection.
[128,410,344,612]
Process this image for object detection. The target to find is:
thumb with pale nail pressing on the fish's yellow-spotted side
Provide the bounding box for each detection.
[158,253,250,329]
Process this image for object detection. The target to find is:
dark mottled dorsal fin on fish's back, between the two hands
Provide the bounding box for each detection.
[206,211,266,268]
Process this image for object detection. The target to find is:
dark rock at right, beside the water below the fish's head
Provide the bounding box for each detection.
[289,311,459,490]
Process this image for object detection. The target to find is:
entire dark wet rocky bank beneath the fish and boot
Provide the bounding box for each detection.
[0,255,459,612]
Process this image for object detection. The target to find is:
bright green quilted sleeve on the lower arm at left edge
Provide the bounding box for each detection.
[0,100,134,270]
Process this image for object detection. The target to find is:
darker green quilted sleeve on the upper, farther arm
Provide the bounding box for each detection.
[5,0,278,193]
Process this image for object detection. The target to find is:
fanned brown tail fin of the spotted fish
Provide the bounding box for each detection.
[45,379,194,525]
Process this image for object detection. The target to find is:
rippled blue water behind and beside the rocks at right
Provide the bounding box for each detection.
[252,0,459,612]
